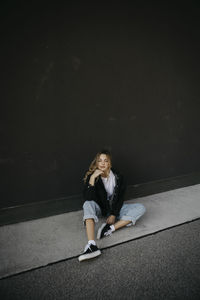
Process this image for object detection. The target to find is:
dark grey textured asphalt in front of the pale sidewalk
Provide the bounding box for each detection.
[0,220,200,300]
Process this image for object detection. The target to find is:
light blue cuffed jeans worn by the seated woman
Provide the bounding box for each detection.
[83,200,146,226]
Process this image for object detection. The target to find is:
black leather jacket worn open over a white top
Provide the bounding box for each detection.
[83,170,126,216]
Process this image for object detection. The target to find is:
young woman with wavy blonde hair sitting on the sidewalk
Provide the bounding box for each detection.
[79,150,146,261]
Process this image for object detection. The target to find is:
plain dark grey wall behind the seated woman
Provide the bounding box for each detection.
[0,1,200,207]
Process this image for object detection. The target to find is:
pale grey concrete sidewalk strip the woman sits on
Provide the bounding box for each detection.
[0,184,200,278]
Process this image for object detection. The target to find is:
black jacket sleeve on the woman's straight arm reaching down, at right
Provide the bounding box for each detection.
[111,176,126,216]
